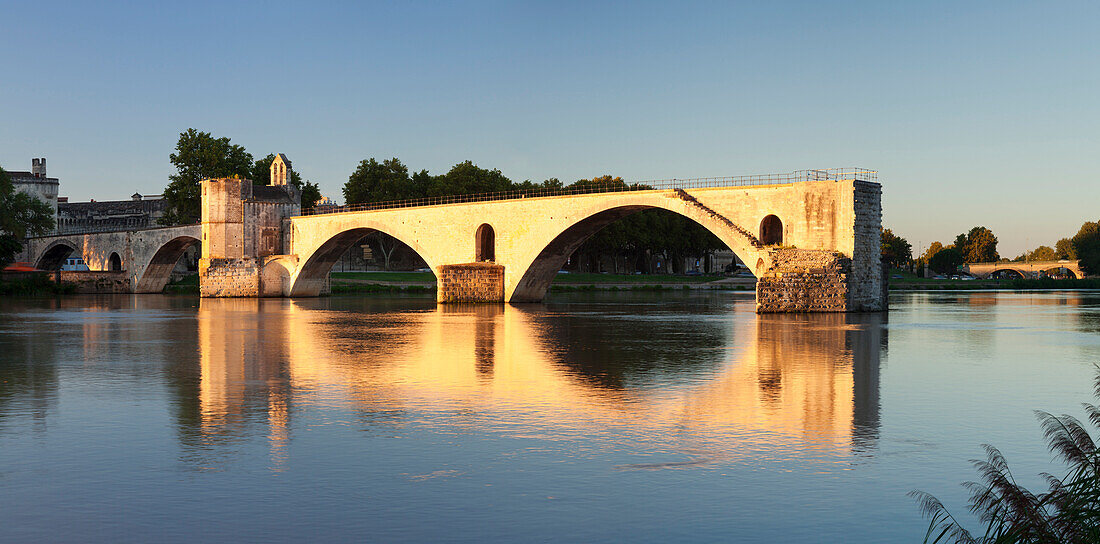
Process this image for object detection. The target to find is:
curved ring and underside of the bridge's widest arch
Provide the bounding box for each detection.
[506,197,770,302]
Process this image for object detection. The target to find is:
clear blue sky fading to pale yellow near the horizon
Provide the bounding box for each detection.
[0,0,1100,257]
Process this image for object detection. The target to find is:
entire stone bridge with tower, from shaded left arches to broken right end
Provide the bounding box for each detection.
[28,170,886,312]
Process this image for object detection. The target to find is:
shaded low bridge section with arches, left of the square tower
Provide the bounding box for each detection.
[24,224,202,292]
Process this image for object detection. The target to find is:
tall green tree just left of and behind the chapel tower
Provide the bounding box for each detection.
[160,129,255,225]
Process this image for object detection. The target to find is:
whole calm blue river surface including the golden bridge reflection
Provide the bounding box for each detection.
[0,292,1100,542]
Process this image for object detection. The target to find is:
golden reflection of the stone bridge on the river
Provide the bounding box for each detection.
[178,299,887,469]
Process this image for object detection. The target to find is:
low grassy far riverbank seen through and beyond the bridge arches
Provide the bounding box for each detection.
[0,271,1100,297]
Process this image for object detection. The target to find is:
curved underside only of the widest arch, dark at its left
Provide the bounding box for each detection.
[509,203,759,302]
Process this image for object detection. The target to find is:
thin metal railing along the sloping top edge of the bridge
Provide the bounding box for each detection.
[301,168,879,215]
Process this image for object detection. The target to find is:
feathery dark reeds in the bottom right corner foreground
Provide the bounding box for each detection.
[910,368,1100,544]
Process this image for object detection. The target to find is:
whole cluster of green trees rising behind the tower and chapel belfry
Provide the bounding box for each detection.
[161,129,321,225]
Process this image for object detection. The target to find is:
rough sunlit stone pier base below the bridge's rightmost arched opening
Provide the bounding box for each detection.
[757,248,856,313]
